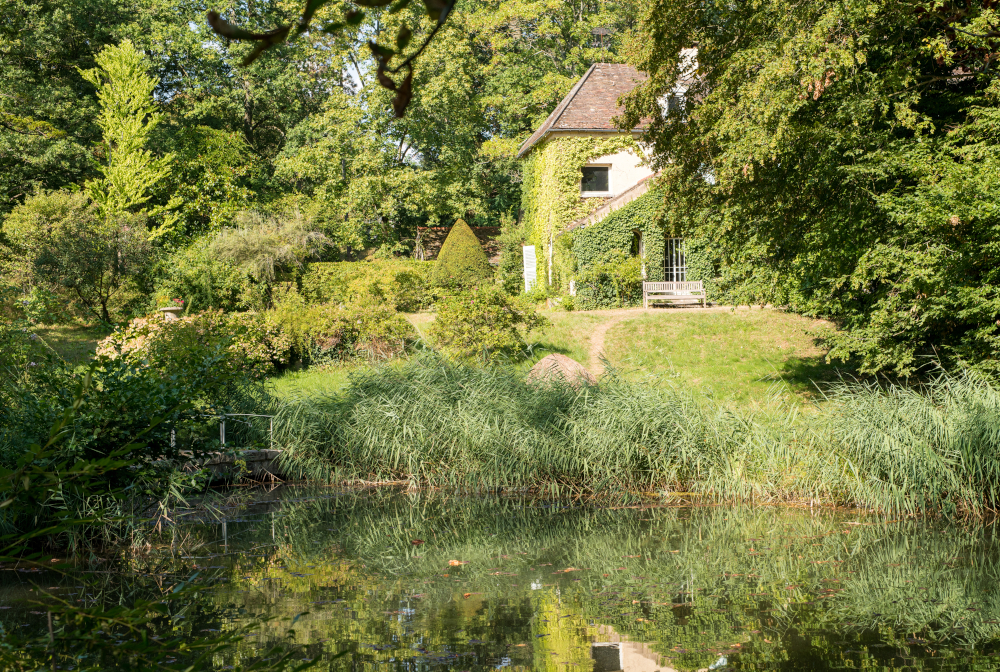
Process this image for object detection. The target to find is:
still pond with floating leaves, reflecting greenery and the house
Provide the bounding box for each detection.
[2,487,1000,672]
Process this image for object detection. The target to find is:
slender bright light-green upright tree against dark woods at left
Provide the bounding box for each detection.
[80,40,173,223]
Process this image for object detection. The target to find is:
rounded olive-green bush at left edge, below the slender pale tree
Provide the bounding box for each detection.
[0,192,151,322]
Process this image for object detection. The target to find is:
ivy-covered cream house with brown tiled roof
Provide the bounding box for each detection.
[517,50,696,293]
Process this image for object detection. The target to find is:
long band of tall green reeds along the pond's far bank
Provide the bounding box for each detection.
[275,357,1000,513]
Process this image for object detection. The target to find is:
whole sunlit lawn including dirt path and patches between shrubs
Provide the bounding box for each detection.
[272,308,838,408]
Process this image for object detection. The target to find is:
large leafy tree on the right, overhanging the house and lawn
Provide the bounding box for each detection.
[621,0,1000,374]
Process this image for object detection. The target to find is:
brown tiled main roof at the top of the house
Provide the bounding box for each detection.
[517,63,646,159]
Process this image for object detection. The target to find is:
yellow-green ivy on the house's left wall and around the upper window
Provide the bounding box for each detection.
[521,134,640,293]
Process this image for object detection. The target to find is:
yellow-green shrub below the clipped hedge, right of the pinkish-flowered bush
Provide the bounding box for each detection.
[268,293,417,365]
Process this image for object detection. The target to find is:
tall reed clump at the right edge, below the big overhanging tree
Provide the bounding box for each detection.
[823,372,1000,514]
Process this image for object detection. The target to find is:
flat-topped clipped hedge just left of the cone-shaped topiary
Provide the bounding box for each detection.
[301,259,436,312]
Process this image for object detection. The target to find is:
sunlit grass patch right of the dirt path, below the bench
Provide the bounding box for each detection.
[605,308,843,406]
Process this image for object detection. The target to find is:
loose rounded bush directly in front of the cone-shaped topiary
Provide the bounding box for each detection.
[430,285,548,361]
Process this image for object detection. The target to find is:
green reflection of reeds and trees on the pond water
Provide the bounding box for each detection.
[189,490,1000,669]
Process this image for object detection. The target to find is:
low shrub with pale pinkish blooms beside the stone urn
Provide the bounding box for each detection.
[97,311,292,378]
